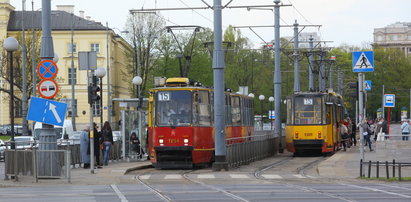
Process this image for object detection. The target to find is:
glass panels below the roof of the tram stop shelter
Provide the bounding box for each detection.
[120,110,148,159]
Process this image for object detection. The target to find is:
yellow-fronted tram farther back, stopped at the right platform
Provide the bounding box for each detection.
[286,92,345,154]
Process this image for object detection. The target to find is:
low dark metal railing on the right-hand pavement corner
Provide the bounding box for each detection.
[360,160,411,181]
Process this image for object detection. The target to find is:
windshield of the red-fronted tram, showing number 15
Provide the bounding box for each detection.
[155,90,193,126]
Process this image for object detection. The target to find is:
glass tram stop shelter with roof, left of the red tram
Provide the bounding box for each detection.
[113,98,148,161]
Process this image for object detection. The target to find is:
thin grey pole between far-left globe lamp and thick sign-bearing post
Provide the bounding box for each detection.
[21,0,29,135]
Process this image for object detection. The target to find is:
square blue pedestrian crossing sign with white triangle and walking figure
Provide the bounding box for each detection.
[352,51,374,72]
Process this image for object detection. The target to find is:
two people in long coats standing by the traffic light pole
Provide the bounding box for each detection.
[80,121,114,169]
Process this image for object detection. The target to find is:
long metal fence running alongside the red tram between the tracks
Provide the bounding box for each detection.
[226,134,279,167]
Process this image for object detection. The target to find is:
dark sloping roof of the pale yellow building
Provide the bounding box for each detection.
[7,11,111,31]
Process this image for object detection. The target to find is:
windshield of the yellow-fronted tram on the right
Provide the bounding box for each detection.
[294,97,326,125]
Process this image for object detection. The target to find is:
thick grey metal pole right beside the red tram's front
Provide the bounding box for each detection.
[213,0,228,171]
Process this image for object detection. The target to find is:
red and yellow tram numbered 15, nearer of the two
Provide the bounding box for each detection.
[148,78,254,168]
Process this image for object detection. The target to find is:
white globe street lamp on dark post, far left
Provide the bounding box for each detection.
[4,37,19,149]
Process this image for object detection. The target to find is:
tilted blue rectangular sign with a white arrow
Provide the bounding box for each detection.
[27,97,67,126]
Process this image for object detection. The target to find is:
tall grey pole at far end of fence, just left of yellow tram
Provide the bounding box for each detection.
[274,0,282,152]
